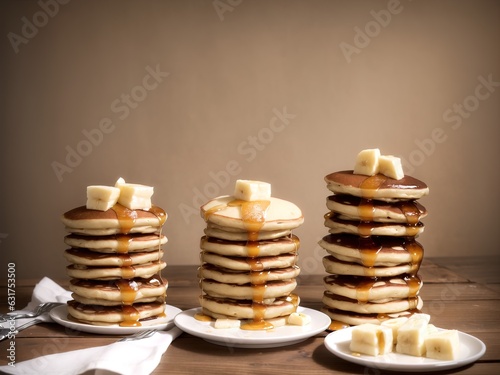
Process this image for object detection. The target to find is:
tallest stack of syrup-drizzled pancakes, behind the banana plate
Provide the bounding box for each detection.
[319,170,429,329]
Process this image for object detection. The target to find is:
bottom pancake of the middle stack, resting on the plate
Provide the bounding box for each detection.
[199,295,299,320]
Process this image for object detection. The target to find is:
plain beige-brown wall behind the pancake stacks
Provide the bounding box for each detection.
[0,0,500,278]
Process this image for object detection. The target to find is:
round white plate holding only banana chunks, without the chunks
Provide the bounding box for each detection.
[325,327,486,372]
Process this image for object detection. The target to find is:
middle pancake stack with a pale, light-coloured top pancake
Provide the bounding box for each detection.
[199,181,304,330]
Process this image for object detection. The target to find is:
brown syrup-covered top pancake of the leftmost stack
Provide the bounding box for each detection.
[61,204,167,236]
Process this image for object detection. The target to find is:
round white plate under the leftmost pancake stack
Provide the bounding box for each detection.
[50,305,182,335]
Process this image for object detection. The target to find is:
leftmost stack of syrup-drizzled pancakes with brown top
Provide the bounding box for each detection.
[62,203,168,327]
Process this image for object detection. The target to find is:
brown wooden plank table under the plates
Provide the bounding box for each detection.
[0,257,500,374]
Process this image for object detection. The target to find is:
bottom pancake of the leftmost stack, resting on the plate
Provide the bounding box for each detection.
[67,301,165,327]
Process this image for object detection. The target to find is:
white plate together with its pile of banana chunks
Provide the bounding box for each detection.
[325,314,486,372]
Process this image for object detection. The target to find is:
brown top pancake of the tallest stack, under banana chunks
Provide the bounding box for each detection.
[325,170,429,202]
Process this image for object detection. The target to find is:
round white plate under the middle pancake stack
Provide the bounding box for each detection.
[175,307,331,348]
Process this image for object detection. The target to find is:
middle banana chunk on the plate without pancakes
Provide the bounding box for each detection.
[396,314,430,357]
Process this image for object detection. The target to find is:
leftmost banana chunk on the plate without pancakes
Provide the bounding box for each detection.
[349,323,393,356]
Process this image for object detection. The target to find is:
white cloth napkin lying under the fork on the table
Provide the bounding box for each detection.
[0,277,182,375]
